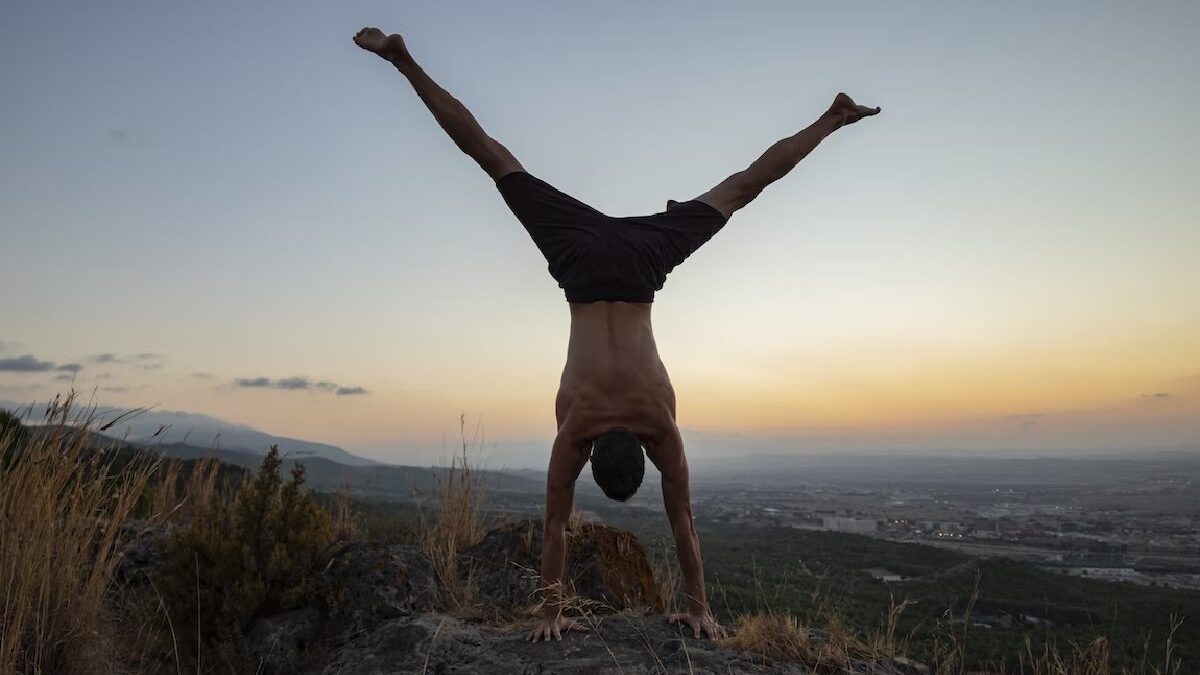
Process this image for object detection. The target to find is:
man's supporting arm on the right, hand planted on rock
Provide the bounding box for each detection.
[650,429,725,639]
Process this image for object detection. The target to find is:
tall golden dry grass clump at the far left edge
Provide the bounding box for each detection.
[0,394,157,674]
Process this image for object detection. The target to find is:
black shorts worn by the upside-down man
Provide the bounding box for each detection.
[496,171,726,303]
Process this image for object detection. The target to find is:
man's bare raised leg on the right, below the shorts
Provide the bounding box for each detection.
[697,94,880,219]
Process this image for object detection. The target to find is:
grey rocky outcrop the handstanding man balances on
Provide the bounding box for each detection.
[120,520,928,675]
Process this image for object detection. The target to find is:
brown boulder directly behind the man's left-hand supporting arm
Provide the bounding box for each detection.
[463,520,662,617]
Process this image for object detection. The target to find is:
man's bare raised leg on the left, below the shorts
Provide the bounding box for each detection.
[354,28,523,180]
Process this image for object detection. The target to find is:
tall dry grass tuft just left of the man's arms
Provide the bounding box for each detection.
[421,416,484,611]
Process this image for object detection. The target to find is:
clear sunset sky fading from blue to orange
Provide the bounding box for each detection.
[0,0,1200,464]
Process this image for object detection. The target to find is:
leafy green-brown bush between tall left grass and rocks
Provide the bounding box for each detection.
[160,446,332,671]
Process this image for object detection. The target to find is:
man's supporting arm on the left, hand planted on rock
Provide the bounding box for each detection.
[529,431,587,643]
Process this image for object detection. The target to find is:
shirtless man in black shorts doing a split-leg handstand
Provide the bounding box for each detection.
[354,28,880,641]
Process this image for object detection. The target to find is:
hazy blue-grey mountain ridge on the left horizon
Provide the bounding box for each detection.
[0,401,384,466]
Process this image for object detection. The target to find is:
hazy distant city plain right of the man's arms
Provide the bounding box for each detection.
[676,455,1200,589]
